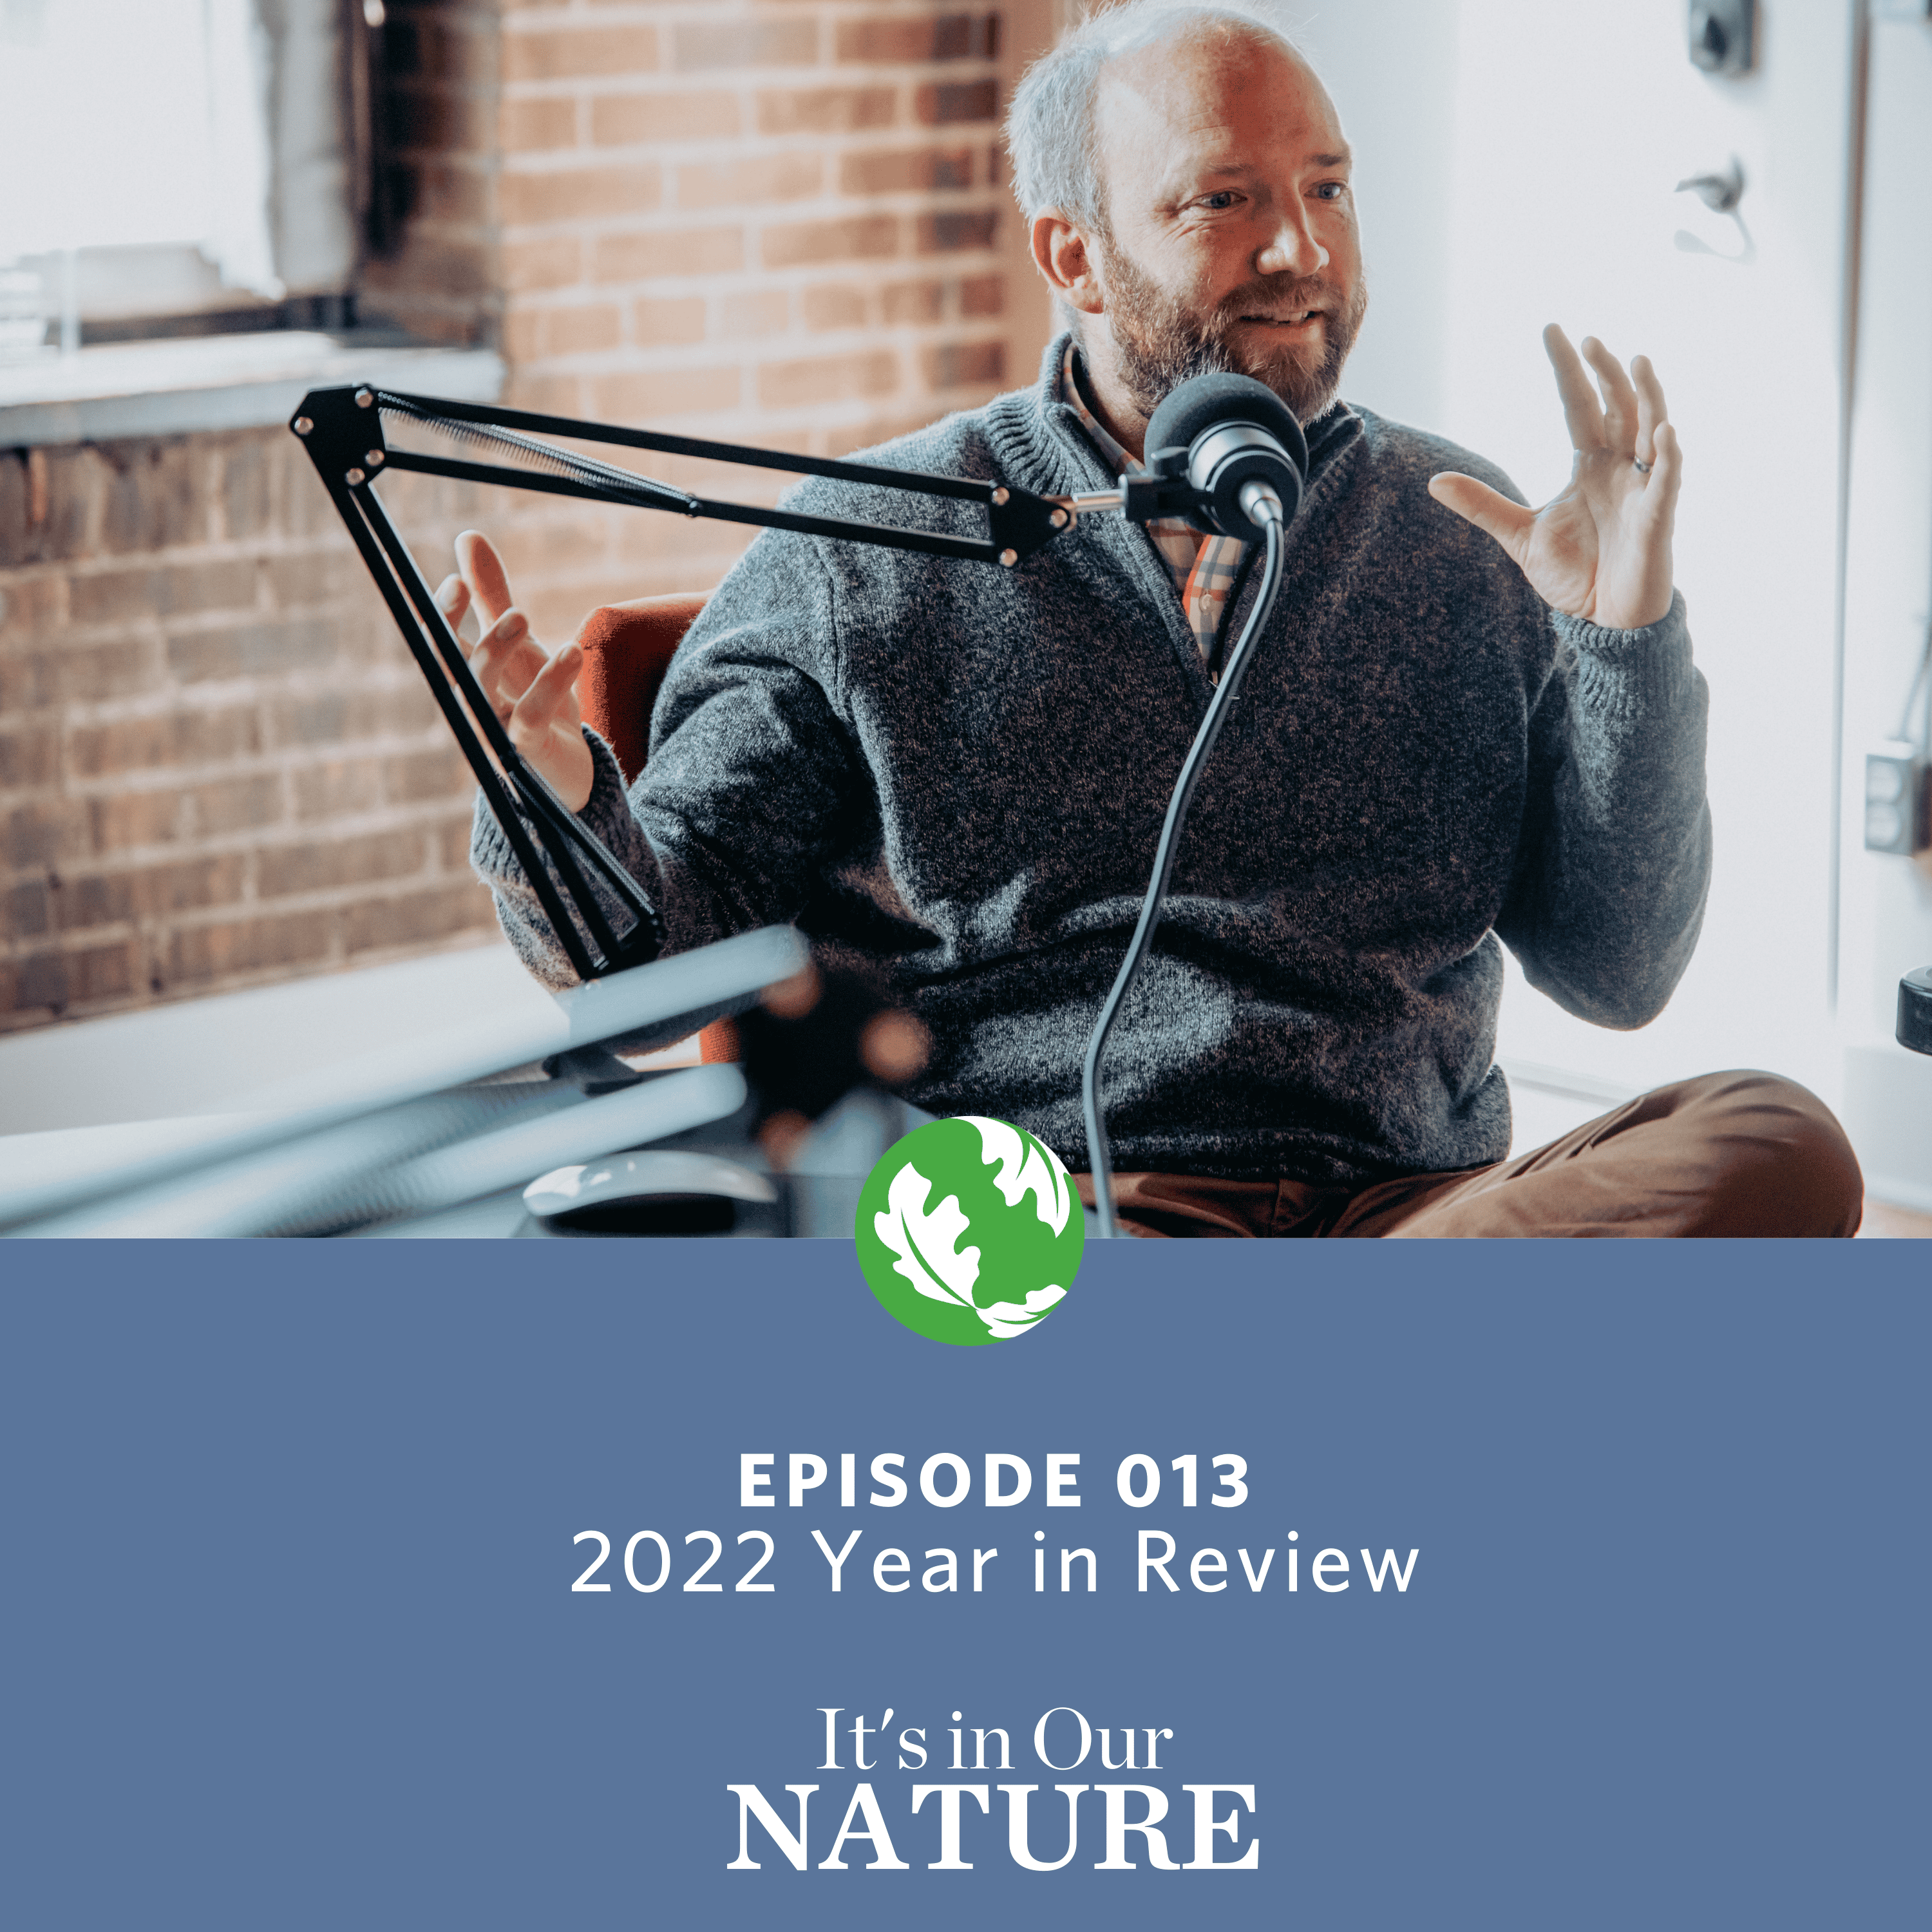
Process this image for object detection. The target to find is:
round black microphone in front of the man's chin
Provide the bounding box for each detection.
[1121,371,1308,543]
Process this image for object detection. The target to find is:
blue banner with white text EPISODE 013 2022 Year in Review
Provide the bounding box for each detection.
[0,1240,1932,1932]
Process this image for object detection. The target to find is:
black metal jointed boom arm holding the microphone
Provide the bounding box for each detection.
[288,386,1076,980]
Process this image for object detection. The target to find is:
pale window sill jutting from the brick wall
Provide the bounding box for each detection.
[0,328,504,448]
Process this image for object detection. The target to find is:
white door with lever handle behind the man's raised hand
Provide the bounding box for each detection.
[1445,0,1851,1099]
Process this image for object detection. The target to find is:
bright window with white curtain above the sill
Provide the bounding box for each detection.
[0,0,381,355]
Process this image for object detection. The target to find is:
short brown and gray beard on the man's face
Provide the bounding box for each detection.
[1099,243,1368,423]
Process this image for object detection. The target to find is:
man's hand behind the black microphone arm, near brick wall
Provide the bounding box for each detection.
[437,529,597,811]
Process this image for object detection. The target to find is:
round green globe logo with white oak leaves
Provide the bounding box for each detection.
[854,1115,1086,1349]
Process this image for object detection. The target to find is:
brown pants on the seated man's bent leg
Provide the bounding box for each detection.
[1074,1072,1864,1238]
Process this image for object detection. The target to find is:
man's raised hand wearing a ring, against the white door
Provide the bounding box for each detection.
[1430,323,1683,630]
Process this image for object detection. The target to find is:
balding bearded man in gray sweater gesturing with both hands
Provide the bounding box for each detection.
[446,0,1862,1235]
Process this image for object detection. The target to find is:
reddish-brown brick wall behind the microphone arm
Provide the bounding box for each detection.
[0,0,1061,1028]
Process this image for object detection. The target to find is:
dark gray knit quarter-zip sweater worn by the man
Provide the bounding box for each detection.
[475,344,1710,1186]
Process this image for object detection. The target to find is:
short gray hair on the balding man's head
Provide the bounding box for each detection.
[1007,0,1298,234]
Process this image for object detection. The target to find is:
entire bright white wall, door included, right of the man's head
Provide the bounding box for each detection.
[1277,0,1932,1208]
